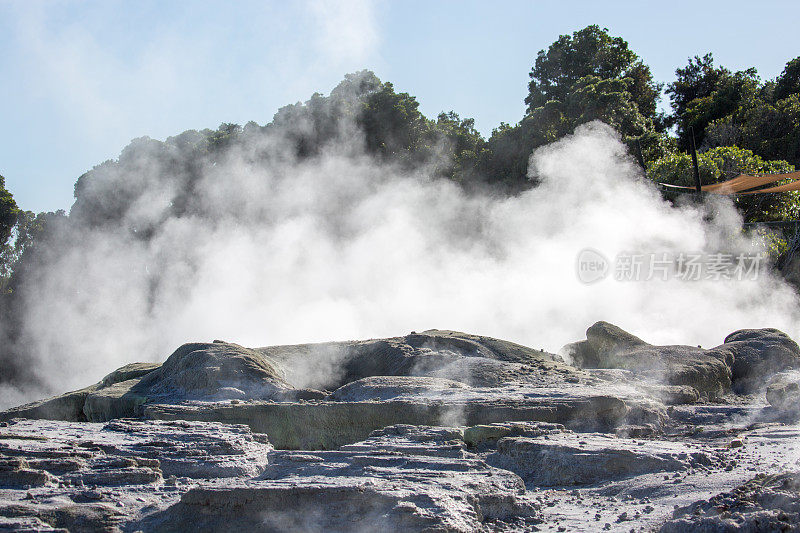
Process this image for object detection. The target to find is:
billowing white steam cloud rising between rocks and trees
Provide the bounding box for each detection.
[2,119,798,402]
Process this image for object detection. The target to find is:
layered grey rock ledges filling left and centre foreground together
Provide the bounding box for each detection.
[0,420,538,531]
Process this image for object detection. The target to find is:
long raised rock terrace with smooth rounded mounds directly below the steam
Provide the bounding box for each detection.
[10,323,788,449]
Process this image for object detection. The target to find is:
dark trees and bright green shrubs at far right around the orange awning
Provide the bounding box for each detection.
[648,54,800,227]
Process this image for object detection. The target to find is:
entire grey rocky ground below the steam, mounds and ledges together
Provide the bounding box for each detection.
[0,322,800,532]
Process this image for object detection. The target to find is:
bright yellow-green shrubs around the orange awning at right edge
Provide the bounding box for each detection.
[647,146,800,222]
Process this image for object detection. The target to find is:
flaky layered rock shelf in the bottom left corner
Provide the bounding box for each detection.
[0,419,272,531]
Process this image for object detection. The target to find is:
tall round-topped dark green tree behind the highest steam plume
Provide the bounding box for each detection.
[466,25,674,191]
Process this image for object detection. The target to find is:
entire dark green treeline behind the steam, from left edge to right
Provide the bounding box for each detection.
[0,25,800,286]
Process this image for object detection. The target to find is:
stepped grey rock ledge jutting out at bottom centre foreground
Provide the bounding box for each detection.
[143,426,538,532]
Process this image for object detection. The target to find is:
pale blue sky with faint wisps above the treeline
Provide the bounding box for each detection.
[0,0,800,211]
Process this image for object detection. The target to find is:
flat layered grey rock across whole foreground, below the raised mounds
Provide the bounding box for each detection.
[0,420,800,532]
